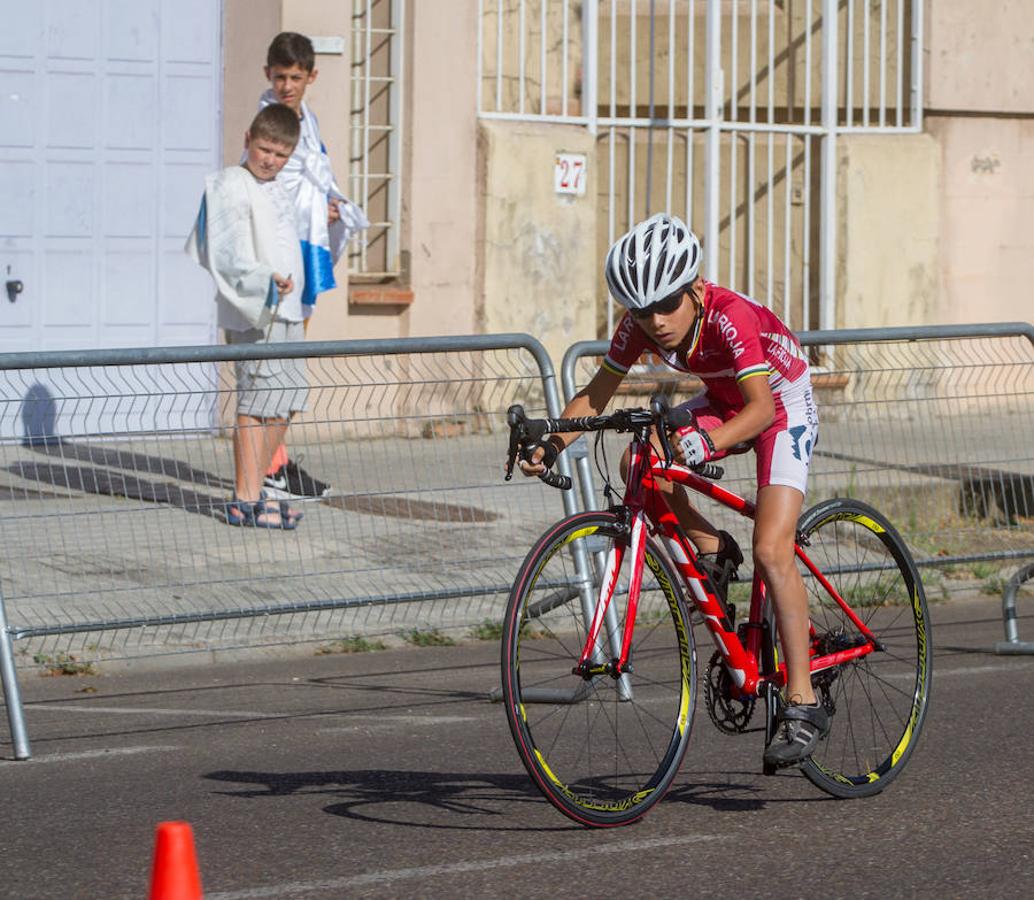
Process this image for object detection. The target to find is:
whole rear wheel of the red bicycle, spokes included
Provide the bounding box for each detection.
[799,500,933,798]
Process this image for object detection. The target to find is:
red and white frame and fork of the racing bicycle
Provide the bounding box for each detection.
[575,436,882,696]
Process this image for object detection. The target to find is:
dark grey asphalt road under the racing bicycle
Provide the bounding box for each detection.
[0,598,1034,900]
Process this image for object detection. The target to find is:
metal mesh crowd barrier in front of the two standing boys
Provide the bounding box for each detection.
[0,334,575,758]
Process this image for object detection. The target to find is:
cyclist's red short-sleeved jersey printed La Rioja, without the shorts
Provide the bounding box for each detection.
[603,281,810,413]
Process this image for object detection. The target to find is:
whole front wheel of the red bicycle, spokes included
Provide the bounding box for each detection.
[503,512,696,827]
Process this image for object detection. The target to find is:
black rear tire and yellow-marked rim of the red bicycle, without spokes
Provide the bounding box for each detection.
[798,498,933,799]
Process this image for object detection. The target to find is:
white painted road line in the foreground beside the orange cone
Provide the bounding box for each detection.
[205,835,719,900]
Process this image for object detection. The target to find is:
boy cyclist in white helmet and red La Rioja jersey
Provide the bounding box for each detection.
[521,214,829,766]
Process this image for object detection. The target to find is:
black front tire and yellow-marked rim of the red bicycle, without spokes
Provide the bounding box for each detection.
[500,512,696,828]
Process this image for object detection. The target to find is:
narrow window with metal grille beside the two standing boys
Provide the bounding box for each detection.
[349,0,405,281]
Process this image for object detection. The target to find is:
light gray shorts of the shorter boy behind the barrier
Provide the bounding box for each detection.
[226,322,309,419]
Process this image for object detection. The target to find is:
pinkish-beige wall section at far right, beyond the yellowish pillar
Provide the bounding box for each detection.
[925,0,1034,323]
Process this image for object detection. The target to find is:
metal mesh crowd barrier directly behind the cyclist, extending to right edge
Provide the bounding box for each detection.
[560,323,1034,653]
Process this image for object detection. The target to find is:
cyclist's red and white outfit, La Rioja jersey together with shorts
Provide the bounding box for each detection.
[603,281,819,493]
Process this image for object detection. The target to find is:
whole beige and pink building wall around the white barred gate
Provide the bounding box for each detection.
[216,0,1034,358]
